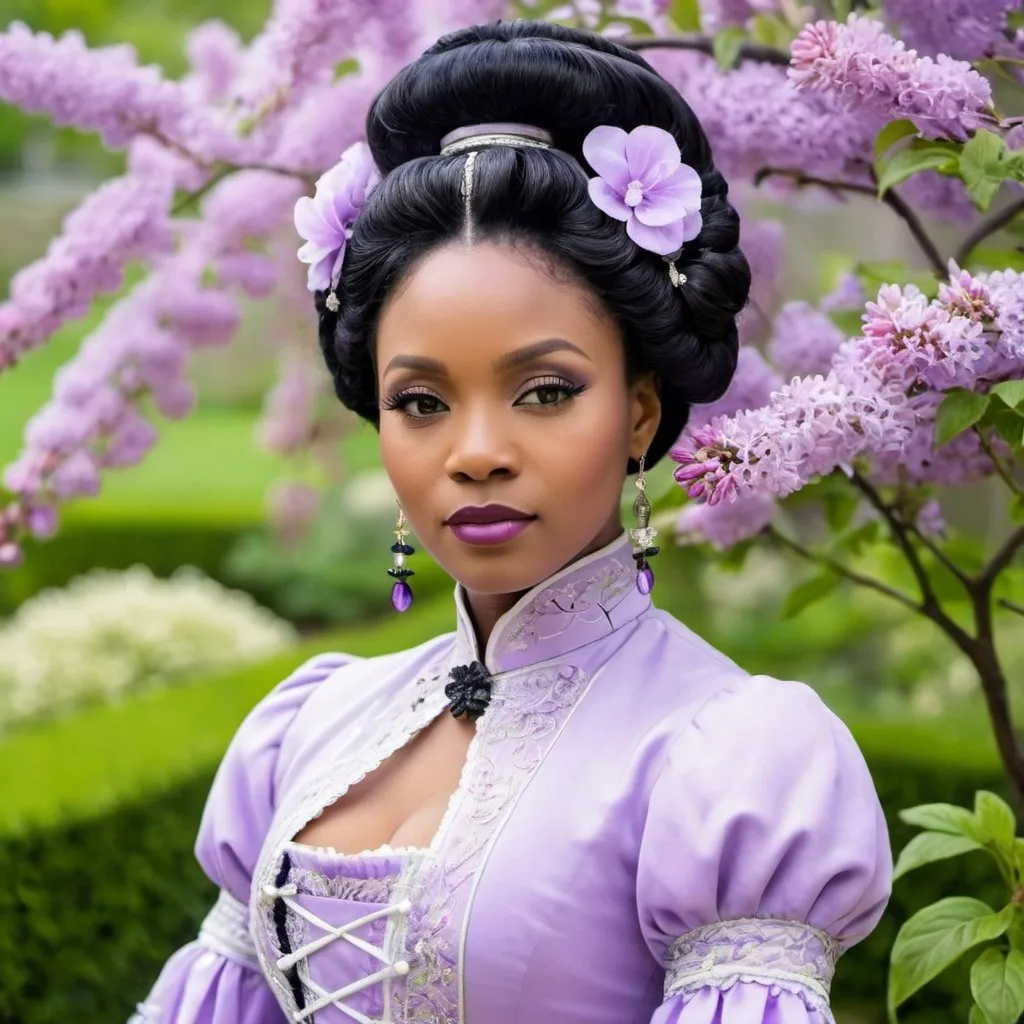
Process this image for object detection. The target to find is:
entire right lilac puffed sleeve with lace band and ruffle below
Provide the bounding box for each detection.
[637,676,893,1024]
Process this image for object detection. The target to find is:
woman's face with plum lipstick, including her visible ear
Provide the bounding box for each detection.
[377,244,660,594]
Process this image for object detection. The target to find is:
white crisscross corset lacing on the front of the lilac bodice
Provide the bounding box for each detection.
[263,885,412,1024]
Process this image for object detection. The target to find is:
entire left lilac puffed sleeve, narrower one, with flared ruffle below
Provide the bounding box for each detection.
[129,654,351,1024]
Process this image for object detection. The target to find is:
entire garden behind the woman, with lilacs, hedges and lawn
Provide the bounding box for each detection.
[0,0,1024,1024]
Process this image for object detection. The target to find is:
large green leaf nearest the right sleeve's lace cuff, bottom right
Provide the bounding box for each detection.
[889,896,1015,1020]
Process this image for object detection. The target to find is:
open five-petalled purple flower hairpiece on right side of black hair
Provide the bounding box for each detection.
[583,125,703,286]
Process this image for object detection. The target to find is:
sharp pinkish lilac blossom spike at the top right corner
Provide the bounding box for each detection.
[790,14,992,139]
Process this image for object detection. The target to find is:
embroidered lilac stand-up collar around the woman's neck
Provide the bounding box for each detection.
[455,531,650,673]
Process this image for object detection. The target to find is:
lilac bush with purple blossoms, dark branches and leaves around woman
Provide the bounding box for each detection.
[0,0,1024,1007]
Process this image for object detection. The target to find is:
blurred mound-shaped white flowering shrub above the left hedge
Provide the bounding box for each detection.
[0,565,296,729]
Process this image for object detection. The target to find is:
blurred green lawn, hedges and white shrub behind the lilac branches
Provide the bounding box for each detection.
[0,0,1024,1024]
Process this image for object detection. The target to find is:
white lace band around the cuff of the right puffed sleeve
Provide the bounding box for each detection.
[665,918,842,1021]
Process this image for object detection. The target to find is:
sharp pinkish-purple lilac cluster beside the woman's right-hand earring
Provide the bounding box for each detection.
[673,264,1024,532]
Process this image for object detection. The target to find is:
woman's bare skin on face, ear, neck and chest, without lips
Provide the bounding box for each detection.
[296,235,662,853]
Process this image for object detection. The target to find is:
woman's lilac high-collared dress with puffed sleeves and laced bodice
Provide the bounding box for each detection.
[133,535,892,1024]
